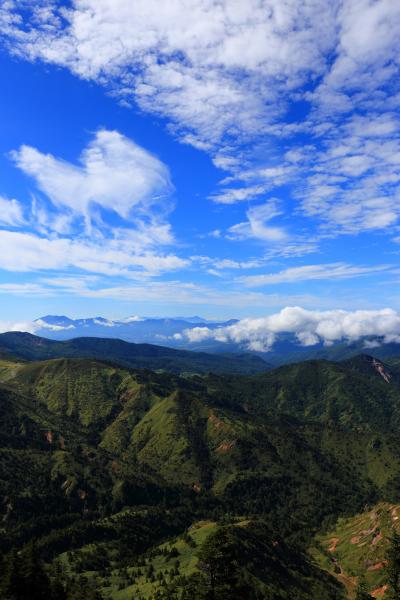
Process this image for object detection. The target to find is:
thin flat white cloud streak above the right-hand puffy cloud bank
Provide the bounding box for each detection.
[241,263,388,287]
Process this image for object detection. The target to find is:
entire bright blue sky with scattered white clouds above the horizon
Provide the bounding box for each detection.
[0,0,400,328]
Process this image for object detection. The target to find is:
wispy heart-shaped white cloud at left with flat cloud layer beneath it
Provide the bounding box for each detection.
[0,130,190,278]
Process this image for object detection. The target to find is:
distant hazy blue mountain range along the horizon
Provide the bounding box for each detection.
[35,315,400,368]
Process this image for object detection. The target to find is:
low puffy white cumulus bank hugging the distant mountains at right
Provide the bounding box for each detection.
[184,306,400,352]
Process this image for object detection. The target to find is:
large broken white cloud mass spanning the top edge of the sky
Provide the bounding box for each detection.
[0,0,400,148]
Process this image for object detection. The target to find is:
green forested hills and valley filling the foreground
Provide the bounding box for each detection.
[0,356,400,600]
